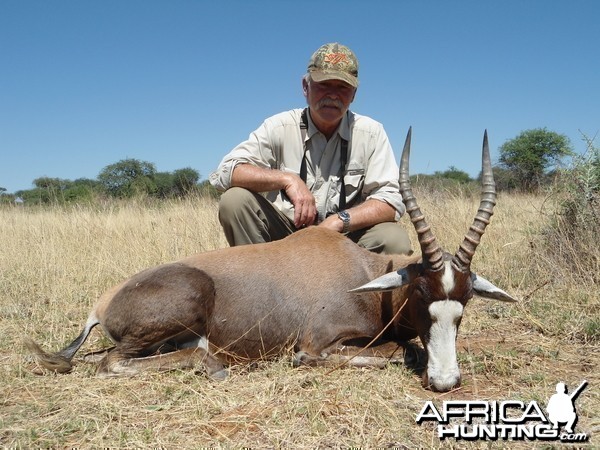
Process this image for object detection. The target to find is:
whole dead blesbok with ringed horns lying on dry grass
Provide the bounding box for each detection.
[28,130,515,391]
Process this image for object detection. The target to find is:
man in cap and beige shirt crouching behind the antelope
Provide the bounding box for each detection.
[210,43,411,254]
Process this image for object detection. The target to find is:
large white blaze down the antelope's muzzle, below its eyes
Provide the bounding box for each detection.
[427,298,464,391]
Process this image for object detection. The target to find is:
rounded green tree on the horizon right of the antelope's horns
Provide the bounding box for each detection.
[499,128,573,191]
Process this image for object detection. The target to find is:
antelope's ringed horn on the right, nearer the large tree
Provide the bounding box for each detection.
[453,130,496,271]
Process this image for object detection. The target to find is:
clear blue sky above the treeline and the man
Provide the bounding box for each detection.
[0,0,600,192]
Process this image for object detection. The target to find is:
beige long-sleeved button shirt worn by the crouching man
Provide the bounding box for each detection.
[209,109,405,222]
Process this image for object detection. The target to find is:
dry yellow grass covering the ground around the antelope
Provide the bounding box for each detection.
[0,192,600,448]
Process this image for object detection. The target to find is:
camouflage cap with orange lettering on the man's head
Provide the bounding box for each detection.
[307,42,358,88]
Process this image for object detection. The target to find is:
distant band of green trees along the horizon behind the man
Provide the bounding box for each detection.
[0,128,573,205]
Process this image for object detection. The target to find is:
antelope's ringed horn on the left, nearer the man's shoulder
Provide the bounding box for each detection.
[398,127,443,271]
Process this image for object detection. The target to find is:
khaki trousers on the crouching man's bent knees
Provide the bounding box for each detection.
[219,187,412,255]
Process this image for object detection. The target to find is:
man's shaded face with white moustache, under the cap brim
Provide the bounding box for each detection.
[302,79,356,127]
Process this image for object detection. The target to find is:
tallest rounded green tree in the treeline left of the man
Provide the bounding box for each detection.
[98,159,156,198]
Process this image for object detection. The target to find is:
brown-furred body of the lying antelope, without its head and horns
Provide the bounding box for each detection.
[30,227,417,377]
